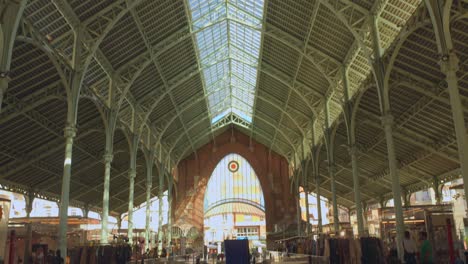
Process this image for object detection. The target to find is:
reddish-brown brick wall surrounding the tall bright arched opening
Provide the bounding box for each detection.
[173,130,297,245]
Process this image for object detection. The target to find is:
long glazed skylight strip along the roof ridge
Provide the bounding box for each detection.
[188,0,264,124]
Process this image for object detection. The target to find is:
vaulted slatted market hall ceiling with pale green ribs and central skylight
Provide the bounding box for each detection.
[0,0,468,212]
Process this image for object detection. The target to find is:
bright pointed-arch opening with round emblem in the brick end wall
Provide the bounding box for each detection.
[203,153,266,253]
